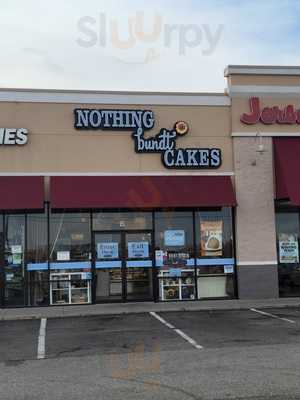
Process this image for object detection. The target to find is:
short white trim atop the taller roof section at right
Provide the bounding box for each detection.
[224,65,300,77]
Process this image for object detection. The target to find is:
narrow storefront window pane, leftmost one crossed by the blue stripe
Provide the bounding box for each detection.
[26,213,49,306]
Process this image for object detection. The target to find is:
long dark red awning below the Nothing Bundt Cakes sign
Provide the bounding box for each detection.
[50,176,236,208]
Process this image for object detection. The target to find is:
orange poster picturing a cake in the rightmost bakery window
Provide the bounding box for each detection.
[200,221,223,257]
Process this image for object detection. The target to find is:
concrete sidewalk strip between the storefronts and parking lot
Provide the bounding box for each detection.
[0,298,300,321]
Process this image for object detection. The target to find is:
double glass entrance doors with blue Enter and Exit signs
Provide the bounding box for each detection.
[94,231,153,302]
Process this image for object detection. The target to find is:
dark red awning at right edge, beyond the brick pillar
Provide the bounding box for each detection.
[273,138,300,206]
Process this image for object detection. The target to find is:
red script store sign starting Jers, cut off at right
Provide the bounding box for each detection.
[241,97,300,125]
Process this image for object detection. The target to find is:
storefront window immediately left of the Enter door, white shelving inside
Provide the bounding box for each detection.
[50,213,92,304]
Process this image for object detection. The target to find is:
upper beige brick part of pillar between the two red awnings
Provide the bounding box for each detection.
[233,137,277,265]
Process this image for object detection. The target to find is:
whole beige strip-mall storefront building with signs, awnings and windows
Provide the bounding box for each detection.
[0,66,300,307]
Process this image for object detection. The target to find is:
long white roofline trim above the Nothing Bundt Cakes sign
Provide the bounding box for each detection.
[0,89,231,106]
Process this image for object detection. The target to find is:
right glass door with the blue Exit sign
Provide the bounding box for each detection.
[125,232,153,300]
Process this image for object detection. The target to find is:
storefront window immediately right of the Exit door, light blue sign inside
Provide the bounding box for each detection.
[155,211,195,300]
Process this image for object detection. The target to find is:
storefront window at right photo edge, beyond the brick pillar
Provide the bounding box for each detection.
[276,210,300,296]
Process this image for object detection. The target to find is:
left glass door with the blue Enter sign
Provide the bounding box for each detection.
[94,232,124,302]
